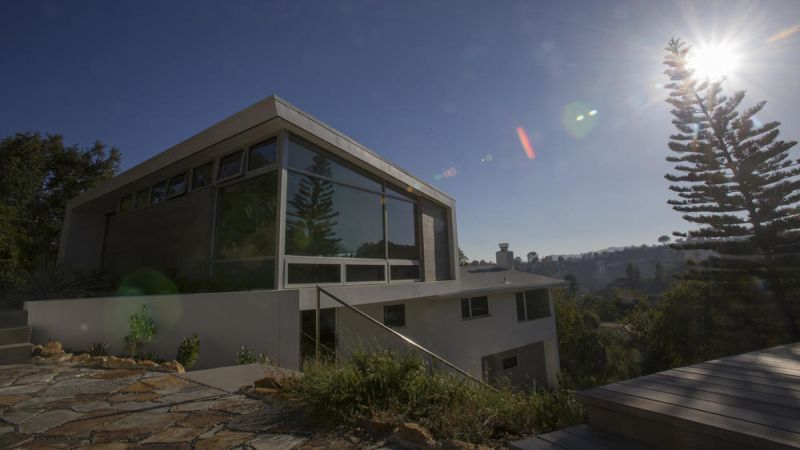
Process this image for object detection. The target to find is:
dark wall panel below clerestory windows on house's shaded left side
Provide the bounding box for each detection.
[101,188,215,278]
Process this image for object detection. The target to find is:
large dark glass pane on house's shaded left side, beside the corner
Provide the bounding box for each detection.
[216,173,277,259]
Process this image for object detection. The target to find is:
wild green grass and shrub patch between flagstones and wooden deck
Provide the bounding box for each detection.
[282,350,584,443]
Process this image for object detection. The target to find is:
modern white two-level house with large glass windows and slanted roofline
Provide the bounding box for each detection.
[26,96,563,386]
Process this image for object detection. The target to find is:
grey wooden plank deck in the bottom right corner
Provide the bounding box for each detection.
[515,343,800,450]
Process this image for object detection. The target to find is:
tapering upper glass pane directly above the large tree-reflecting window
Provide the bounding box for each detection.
[289,136,382,192]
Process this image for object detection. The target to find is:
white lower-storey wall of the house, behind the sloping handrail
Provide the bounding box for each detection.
[336,292,559,386]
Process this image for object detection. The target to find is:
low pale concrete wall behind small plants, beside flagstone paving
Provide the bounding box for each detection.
[25,290,300,369]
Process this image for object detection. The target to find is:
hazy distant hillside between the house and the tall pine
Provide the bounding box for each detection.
[516,245,705,293]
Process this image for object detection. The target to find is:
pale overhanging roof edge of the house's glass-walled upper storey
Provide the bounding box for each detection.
[67,95,455,209]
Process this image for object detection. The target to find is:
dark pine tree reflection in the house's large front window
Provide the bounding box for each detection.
[287,155,341,256]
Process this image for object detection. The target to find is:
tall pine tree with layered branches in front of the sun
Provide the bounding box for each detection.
[664,39,800,340]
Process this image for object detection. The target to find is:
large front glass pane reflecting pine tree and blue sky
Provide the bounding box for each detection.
[286,173,386,259]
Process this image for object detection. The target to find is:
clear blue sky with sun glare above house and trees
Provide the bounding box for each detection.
[0,1,800,259]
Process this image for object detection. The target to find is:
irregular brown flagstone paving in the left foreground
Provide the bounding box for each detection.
[0,364,332,450]
